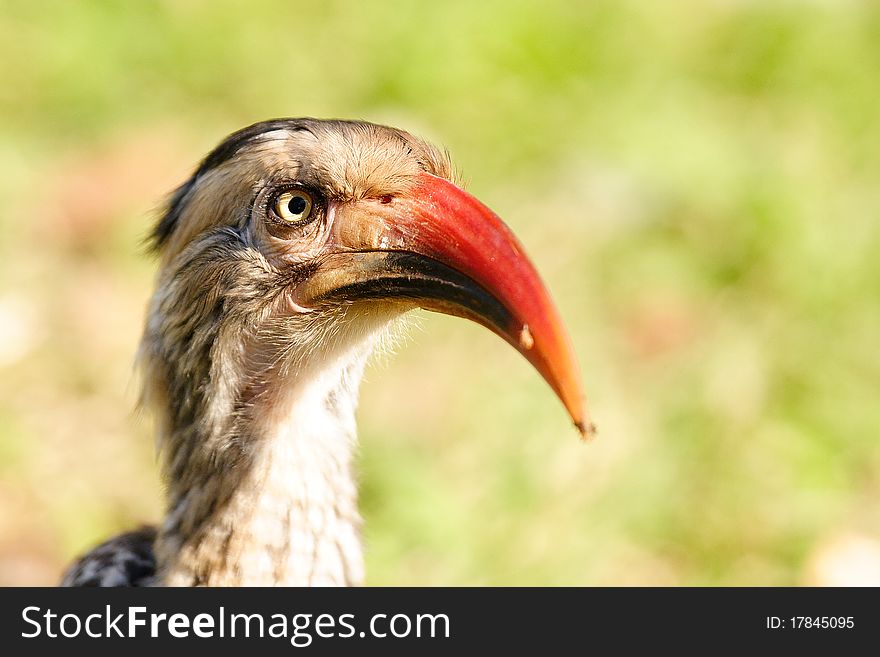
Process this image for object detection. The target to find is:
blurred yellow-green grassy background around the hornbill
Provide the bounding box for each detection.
[0,0,880,585]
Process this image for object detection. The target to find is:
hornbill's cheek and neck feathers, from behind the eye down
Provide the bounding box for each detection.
[141,233,393,586]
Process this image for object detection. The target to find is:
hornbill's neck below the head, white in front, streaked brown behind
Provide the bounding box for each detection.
[156,341,372,586]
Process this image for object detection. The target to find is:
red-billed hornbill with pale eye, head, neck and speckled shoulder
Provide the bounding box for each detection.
[64,119,590,586]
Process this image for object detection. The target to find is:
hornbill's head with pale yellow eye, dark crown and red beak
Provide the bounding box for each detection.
[143,119,590,444]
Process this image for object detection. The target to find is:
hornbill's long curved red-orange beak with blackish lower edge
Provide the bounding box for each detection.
[298,173,595,437]
